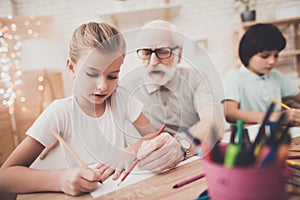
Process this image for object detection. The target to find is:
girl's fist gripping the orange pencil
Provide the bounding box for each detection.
[60,168,100,196]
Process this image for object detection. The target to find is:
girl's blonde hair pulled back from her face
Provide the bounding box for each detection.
[69,22,126,63]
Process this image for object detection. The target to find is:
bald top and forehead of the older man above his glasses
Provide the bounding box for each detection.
[137,28,176,47]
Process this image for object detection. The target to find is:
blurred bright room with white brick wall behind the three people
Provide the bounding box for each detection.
[0,0,300,165]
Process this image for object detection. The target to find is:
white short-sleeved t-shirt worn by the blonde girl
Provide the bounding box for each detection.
[26,87,143,167]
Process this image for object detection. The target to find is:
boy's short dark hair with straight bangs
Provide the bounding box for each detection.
[239,24,286,67]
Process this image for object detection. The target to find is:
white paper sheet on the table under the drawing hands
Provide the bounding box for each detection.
[91,156,199,198]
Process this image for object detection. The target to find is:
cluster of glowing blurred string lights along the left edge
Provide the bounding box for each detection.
[0,15,42,115]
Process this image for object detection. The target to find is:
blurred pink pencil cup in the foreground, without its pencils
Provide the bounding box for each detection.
[203,145,289,200]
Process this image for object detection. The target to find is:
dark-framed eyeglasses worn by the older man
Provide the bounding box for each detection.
[136,46,179,60]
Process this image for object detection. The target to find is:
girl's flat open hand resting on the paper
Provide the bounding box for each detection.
[96,148,136,181]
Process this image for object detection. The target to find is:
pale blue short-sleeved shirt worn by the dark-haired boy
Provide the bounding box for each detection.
[224,66,300,112]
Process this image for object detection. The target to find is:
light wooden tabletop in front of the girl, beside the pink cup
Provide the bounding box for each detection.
[17,160,207,200]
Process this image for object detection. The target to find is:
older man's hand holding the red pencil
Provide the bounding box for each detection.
[137,132,184,173]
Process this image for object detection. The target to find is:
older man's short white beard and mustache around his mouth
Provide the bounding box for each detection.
[147,64,176,86]
